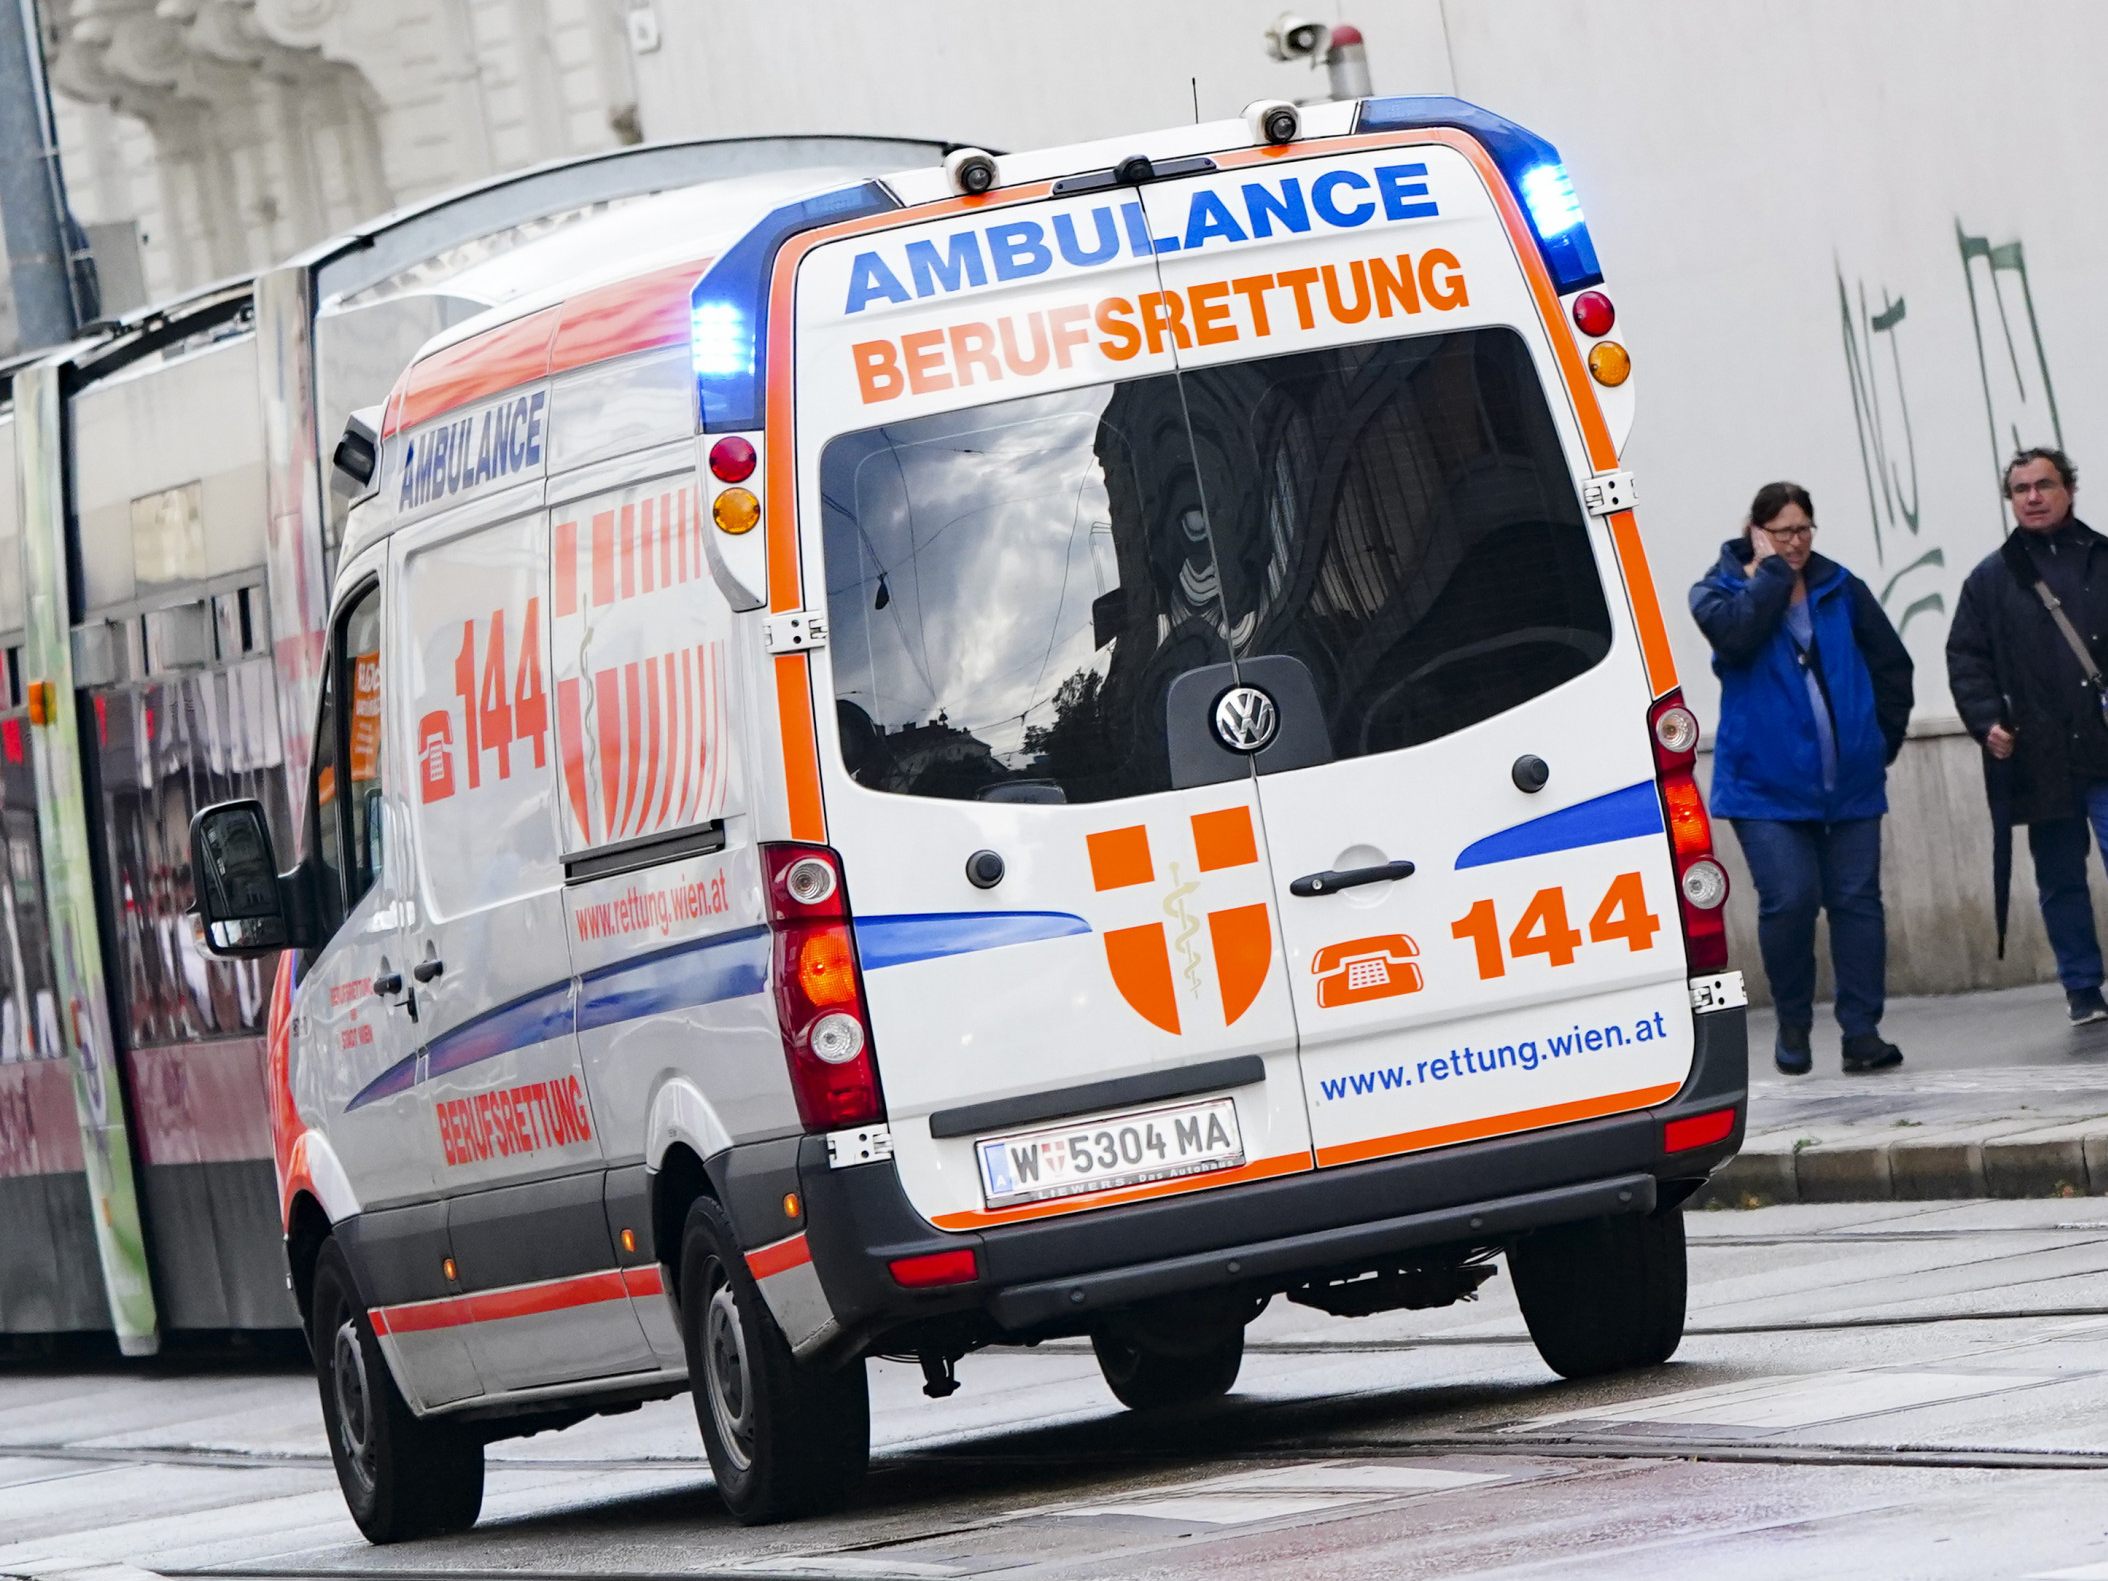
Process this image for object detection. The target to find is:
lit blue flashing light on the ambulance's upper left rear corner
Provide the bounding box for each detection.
[689,181,900,434]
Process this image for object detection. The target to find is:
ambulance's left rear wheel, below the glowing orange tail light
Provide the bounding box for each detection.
[681,1197,871,1526]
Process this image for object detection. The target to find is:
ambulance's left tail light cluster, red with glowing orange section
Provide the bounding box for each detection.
[761,845,885,1130]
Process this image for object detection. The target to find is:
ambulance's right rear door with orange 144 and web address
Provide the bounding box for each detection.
[1147,135,1693,1189]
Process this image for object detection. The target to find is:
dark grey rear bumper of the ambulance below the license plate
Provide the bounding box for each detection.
[797,1008,1748,1355]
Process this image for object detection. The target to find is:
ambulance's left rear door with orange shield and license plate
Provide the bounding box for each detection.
[797,192,1311,1229]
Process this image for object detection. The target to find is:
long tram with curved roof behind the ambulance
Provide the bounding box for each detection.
[0,137,951,1355]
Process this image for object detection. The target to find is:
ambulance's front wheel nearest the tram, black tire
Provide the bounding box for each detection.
[310,1237,483,1543]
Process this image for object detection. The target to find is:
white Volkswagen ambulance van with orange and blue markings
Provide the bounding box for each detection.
[194,99,1745,1541]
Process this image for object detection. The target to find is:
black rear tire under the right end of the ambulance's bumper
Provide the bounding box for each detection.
[1507,1208,1686,1379]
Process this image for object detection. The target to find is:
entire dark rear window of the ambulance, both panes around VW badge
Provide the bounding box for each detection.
[820,329,1611,803]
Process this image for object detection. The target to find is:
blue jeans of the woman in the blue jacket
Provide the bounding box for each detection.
[1733,818,1897,1037]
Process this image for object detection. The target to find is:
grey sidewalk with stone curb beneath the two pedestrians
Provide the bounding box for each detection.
[1693,982,2108,1208]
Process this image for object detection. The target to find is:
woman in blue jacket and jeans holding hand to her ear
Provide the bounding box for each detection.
[1691,483,1912,1075]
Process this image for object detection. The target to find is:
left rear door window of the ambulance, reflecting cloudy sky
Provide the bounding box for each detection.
[820,377,1229,803]
